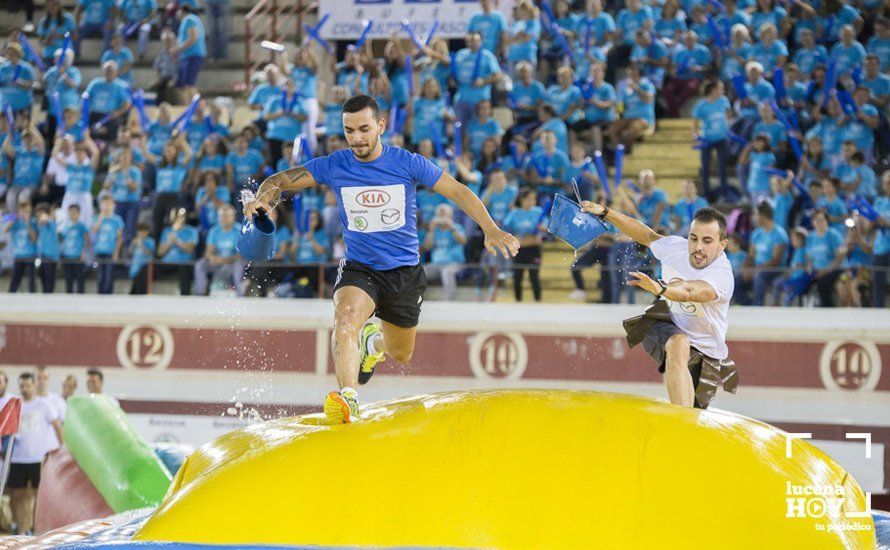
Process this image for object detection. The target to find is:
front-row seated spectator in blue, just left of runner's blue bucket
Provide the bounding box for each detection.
[195,204,244,296]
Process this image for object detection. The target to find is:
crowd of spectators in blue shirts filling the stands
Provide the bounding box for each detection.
[0,0,890,306]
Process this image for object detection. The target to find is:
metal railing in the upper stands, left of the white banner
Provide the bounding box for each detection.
[244,0,317,86]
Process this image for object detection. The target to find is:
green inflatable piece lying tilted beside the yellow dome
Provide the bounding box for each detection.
[63,394,171,513]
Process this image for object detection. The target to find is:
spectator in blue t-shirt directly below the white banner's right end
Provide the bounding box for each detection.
[452,32,502,126]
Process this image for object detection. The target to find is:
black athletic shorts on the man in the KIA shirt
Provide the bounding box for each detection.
[334,259,426,328]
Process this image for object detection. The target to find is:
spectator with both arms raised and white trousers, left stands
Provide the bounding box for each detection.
[52,132,100,225]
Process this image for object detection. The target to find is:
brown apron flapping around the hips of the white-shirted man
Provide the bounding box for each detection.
[622,298,739,409]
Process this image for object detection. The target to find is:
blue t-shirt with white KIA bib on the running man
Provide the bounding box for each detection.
[304,145,442,270]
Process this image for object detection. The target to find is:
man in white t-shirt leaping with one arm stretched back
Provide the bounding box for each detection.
[581,201,738,408]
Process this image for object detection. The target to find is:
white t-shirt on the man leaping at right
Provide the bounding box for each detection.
[649,237,735,359]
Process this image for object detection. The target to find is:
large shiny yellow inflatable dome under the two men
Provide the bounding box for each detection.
[134,390,875,550]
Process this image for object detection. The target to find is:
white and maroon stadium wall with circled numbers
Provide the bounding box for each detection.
[0,295,890,500]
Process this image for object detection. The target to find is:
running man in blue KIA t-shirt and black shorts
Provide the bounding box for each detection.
[244,95,519,423]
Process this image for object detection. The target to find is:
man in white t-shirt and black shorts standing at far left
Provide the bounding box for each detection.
[7,372,62,535]
